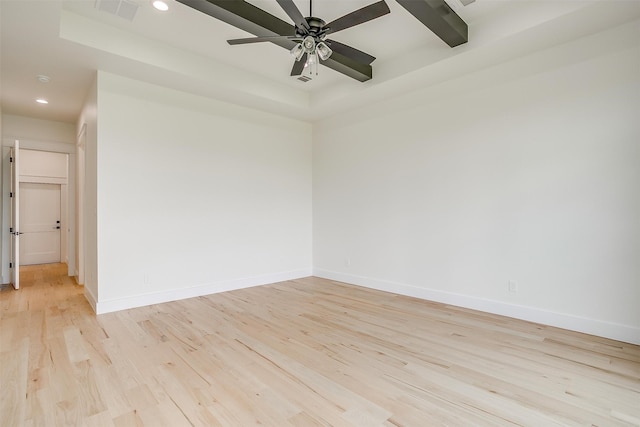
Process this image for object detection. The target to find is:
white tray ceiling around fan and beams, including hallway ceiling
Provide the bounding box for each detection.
[0,0,640,123]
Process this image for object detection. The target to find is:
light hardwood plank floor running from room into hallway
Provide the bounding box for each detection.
[0,264,640,427]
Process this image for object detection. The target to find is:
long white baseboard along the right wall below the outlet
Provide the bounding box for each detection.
[313,269,640,344]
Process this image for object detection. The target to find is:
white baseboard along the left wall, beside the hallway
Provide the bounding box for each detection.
[91,269,311,314]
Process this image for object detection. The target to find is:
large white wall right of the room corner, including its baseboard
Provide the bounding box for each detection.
[313,24,640,343]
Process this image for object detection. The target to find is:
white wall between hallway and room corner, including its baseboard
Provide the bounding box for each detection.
[87,73,311,312]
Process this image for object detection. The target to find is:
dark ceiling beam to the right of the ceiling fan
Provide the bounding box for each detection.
[397,0,469,47]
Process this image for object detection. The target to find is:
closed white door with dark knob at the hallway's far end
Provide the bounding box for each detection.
[19,182,62,265]
